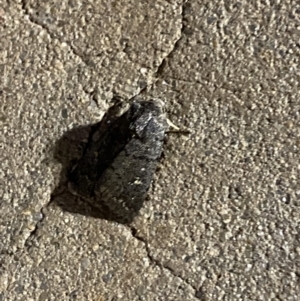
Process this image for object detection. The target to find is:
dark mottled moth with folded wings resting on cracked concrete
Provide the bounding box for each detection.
[68,100,168,221]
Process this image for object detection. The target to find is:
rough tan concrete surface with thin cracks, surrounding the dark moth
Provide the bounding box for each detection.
[0,0,300,301]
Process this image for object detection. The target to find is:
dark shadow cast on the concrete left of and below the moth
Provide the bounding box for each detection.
[51,123,143,224]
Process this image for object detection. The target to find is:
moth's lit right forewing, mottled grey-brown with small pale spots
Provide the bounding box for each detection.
[94,118,165,220]
